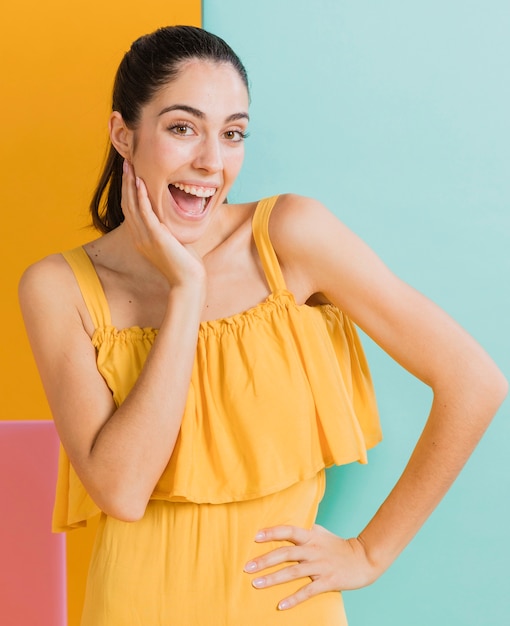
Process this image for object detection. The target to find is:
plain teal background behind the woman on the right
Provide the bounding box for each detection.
[203,0,510,626]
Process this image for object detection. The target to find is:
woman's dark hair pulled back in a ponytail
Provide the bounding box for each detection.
[90,26,249,233]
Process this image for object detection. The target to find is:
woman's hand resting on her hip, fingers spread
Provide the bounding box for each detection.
[244,525,380,610]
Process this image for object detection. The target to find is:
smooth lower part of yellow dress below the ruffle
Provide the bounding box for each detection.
[81,472,347,626]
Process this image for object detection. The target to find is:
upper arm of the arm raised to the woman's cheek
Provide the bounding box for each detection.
[19,255,115,472]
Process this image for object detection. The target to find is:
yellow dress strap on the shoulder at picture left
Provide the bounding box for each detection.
[62,247,111,329]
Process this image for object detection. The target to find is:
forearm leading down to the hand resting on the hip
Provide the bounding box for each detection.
[359,367,506,577]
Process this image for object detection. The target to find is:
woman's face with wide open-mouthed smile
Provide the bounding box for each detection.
[125,60,248,243]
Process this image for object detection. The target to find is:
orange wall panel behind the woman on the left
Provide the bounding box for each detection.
[0,0,201,626]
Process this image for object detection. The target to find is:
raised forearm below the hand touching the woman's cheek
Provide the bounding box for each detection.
[82,288,203,519]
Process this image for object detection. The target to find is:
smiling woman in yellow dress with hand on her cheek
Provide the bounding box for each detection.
[20,27,507,626]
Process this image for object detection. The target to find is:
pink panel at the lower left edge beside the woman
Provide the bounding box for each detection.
[0,421,67,626]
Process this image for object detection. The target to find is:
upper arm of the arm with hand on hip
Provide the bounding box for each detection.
[270,196,504,391]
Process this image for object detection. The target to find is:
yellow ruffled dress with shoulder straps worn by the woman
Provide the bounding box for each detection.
[54,197,381,626]
